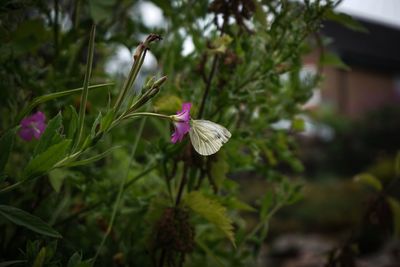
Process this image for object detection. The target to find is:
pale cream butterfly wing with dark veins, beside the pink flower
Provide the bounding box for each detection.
[189,120,231,156]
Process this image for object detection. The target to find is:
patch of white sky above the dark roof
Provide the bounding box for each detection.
[338,0,400,28]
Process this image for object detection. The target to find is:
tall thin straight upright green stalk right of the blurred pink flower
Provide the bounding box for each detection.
[72,24,96,151]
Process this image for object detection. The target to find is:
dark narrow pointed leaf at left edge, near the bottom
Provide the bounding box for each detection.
[0,205,62,238]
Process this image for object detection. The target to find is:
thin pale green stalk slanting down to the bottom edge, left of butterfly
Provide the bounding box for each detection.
[93,118,146,265]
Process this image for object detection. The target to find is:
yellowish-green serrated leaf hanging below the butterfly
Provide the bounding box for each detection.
[184,191,236,246]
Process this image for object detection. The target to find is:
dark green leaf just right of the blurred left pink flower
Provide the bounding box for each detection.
[33,113,62,156]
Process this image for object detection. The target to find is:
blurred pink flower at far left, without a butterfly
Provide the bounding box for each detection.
[18,111,46,141]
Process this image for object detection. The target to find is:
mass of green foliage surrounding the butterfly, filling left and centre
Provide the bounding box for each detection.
[0,0,350,266]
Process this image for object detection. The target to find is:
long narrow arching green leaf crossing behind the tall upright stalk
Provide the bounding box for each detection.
[16,83,114,122]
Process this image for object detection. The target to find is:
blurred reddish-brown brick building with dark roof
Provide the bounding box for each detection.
[305,18,400,118]
